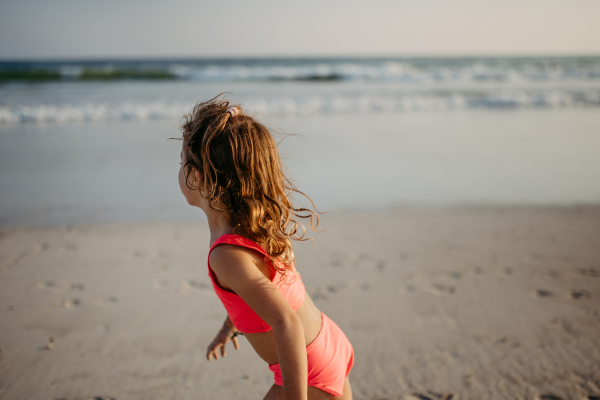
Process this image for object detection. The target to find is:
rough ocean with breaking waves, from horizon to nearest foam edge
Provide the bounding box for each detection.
[0,57,600,123]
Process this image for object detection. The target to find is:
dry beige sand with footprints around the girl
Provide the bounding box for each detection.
[0,207,600,400]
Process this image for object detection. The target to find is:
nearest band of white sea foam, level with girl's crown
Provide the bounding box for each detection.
[0,90,600,123]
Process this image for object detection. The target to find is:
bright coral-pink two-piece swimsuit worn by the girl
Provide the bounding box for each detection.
[208,235,354,397]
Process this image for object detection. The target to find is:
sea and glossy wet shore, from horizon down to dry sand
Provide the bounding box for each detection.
[0,57,600,225]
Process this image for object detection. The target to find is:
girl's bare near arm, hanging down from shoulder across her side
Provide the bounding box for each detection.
[209,244,308,400]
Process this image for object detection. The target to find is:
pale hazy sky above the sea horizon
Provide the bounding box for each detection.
[0,0,600,59]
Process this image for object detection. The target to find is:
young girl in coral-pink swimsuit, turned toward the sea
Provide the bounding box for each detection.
[179,96,354,400]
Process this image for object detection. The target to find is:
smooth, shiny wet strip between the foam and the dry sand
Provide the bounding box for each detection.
[0,108,600,226]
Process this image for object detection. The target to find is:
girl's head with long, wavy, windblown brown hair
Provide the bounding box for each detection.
[180,96,318,273]
